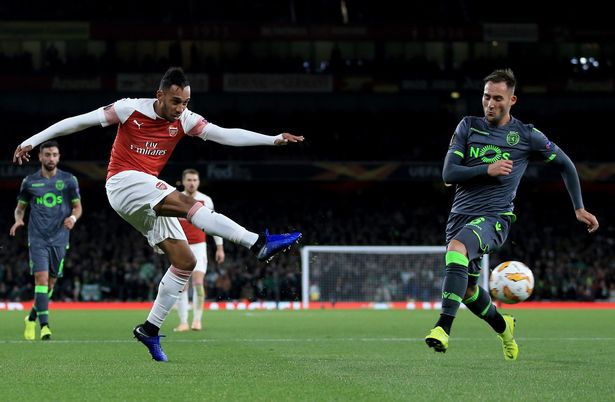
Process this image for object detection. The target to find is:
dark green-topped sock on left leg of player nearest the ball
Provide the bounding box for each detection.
[436,251,468,333]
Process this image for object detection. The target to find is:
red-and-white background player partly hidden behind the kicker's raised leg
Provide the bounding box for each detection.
[174,169,224,332]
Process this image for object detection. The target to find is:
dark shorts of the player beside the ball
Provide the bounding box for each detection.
[446,213,511,284]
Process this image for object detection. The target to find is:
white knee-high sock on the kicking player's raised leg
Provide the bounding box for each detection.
[186,203,258,248]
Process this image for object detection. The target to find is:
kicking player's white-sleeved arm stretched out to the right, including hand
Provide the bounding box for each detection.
[200,123,304,147]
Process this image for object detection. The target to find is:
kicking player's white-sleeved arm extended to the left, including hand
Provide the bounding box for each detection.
[13,110,101,165]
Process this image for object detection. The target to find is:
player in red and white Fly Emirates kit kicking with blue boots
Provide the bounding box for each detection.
[13,67,303,361]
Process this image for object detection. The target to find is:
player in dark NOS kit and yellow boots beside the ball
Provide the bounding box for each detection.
[425,69,598,360]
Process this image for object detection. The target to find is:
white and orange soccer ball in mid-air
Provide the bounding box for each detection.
[489,261,534,304]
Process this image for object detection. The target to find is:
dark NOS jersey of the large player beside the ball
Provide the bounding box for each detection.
[447,116,561,216]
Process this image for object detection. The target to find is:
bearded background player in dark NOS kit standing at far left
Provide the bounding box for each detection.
[10,141,82,341]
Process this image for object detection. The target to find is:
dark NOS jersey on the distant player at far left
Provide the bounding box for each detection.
[17,169,81,246]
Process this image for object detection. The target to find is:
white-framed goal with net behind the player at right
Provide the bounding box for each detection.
[301,246,489,308]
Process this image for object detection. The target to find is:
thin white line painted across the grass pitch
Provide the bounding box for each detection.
[0,337,615,345]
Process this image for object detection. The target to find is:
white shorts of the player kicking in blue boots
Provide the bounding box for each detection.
[105,170,186,252]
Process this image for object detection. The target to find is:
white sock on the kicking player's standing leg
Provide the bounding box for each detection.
[147,265,192,328]
